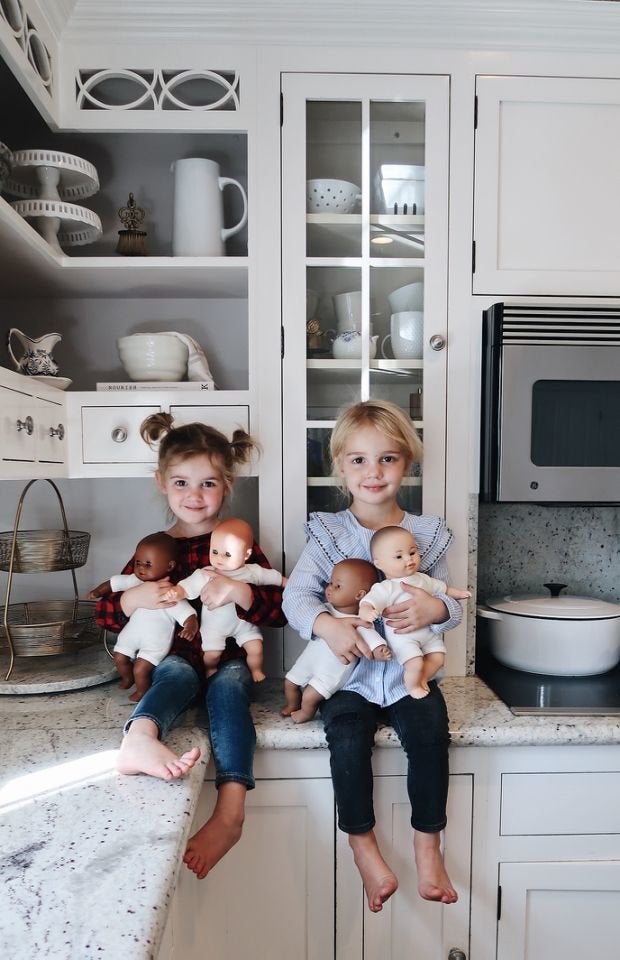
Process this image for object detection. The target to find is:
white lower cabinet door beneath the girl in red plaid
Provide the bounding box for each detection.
[172,778,334,960]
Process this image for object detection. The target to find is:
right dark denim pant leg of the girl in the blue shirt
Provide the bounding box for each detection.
[387,682,450,833]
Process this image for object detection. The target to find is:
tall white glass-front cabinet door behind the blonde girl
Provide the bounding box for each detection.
[282,74,449,570]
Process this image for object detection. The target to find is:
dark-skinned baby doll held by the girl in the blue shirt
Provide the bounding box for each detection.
[280,559,392,723]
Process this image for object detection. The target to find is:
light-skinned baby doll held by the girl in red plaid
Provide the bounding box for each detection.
[164,518,286,681]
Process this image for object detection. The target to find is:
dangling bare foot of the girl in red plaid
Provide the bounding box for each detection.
[183,781,247,880]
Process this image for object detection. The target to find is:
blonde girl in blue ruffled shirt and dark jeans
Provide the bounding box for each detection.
[283,400,462,913]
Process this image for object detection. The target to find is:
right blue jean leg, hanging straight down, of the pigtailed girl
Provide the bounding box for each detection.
[206,660,256,790]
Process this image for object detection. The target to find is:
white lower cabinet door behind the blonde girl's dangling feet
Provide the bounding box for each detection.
[336,774,473,960]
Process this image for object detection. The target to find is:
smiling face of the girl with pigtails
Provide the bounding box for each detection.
[155,454,227,535]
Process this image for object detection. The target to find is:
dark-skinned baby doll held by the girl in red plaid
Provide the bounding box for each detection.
[88,533,198,701]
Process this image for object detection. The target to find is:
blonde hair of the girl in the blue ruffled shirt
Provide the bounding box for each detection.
[329,400,422,476]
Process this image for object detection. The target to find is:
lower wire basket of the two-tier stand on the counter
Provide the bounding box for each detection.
[0,600,96,657]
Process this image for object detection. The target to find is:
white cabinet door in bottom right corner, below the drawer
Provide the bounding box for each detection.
[497,861,620,960]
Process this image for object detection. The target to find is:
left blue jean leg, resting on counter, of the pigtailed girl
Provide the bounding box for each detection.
[123,654,200,740]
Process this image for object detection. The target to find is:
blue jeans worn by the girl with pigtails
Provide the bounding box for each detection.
[125,655,256,790]
